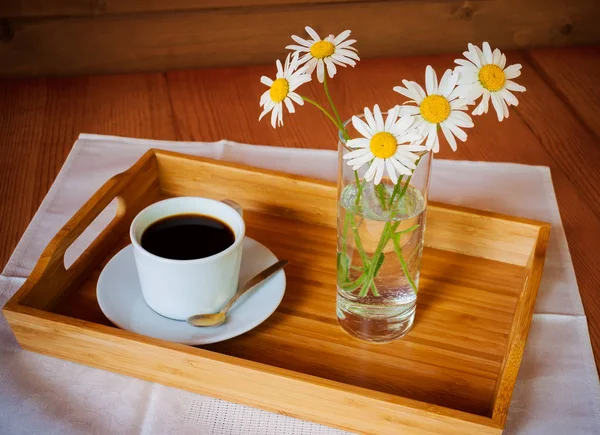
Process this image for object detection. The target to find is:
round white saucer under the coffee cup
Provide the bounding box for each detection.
[96,237,285,345]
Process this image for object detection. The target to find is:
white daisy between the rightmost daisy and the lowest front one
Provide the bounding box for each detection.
[394,65,473,153]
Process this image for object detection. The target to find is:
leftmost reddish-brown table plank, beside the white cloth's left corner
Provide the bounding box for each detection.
[0,74,177,272]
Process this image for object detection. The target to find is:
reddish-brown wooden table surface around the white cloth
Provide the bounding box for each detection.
[0,47,600,372]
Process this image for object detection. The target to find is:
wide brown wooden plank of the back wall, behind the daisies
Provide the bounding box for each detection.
[0,0,600,76]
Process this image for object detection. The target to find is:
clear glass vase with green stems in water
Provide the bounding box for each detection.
[336,116,433,342]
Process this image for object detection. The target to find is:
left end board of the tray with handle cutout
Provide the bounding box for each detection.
[14,150,160,310]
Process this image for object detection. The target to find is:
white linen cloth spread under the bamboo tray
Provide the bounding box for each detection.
[0,134,600,435]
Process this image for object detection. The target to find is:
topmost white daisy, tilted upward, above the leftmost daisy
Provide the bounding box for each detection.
[285,26,360,83]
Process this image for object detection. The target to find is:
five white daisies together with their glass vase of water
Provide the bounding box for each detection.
[259,27,525,342]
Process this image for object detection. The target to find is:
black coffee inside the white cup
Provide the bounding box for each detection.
[142,214,235,260]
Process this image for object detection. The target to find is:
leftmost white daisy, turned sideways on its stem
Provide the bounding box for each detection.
[258,54,310,128]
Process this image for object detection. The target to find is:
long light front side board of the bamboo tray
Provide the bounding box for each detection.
[4,307,502,435]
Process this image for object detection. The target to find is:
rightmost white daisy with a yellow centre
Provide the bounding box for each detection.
[454,42,525,121]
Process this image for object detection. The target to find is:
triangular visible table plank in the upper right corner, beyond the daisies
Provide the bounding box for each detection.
[529,47,600,140]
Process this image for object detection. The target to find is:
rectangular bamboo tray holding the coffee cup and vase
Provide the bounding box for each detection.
[4,150,550,435]
